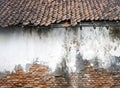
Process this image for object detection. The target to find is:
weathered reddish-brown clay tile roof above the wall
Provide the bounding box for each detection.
[0,0,120,27]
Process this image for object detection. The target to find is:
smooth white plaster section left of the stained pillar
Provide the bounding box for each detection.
[0,29,64,70]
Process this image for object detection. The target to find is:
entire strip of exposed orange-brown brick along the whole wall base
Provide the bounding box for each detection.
[0,64,120,88]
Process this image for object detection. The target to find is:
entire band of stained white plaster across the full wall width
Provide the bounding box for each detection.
[0,27,120,72]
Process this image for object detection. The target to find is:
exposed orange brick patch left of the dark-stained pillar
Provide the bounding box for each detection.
[0,64,55,88]
